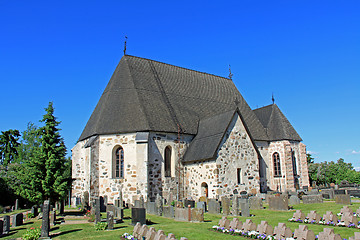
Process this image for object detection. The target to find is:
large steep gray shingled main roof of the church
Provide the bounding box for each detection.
[79,55,268,140]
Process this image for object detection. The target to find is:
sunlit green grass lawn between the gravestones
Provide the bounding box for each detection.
[2,201,360,240]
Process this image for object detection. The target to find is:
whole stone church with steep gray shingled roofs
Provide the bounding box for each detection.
[72,55,309,206]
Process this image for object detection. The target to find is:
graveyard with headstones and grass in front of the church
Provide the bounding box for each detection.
[0,194,360,239]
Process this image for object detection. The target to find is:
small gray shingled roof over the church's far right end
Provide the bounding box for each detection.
[254,104,302,141]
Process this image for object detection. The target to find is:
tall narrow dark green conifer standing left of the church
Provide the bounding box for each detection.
[35,102,69,202]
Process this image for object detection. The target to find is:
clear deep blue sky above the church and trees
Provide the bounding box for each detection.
[0,0,360,167]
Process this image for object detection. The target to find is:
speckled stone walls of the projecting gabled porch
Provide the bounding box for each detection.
[185,115,260,199]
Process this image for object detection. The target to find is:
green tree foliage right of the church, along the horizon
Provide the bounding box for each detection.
[308,154,360,185]
